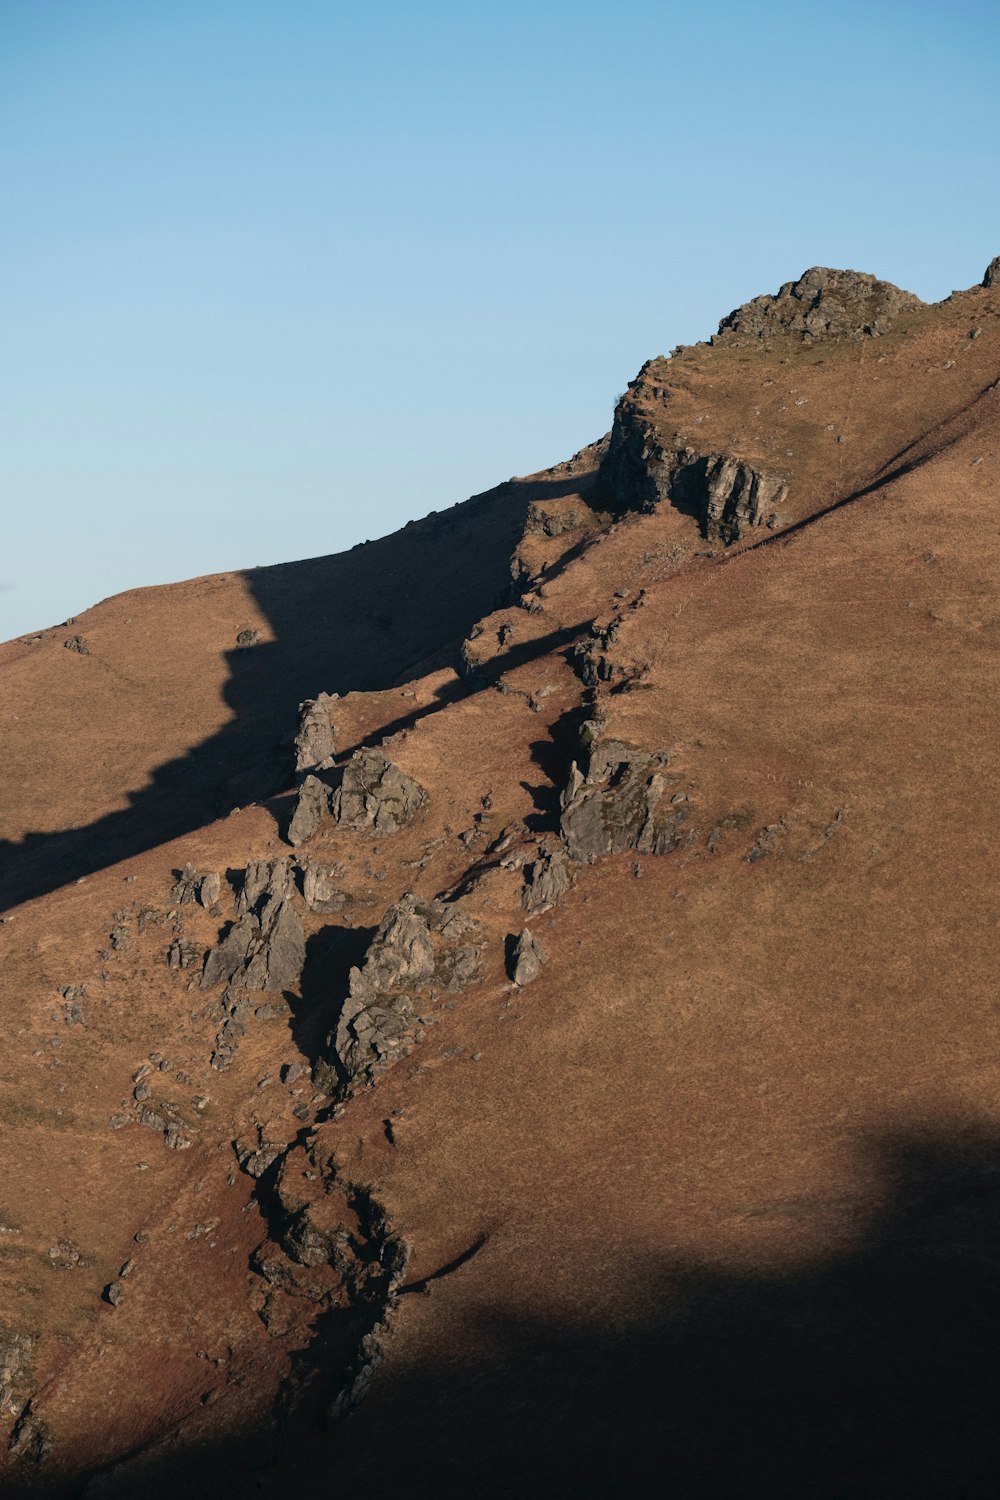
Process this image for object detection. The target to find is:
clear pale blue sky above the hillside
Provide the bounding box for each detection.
[0,0,1000,639]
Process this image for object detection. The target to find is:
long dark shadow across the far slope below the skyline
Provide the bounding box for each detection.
[0,479,590,909]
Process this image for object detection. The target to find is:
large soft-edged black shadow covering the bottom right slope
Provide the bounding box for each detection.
[17,1128,1000,1500]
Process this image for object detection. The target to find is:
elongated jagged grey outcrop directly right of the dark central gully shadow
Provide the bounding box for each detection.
[315,896,483,1094]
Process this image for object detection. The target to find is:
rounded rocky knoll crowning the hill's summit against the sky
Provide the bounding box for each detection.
[718,266,924,341]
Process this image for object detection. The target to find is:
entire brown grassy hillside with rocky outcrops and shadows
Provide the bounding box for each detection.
[0,270,1000,1497]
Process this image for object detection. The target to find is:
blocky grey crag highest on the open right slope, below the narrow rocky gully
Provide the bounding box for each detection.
[561,725,688,861]
